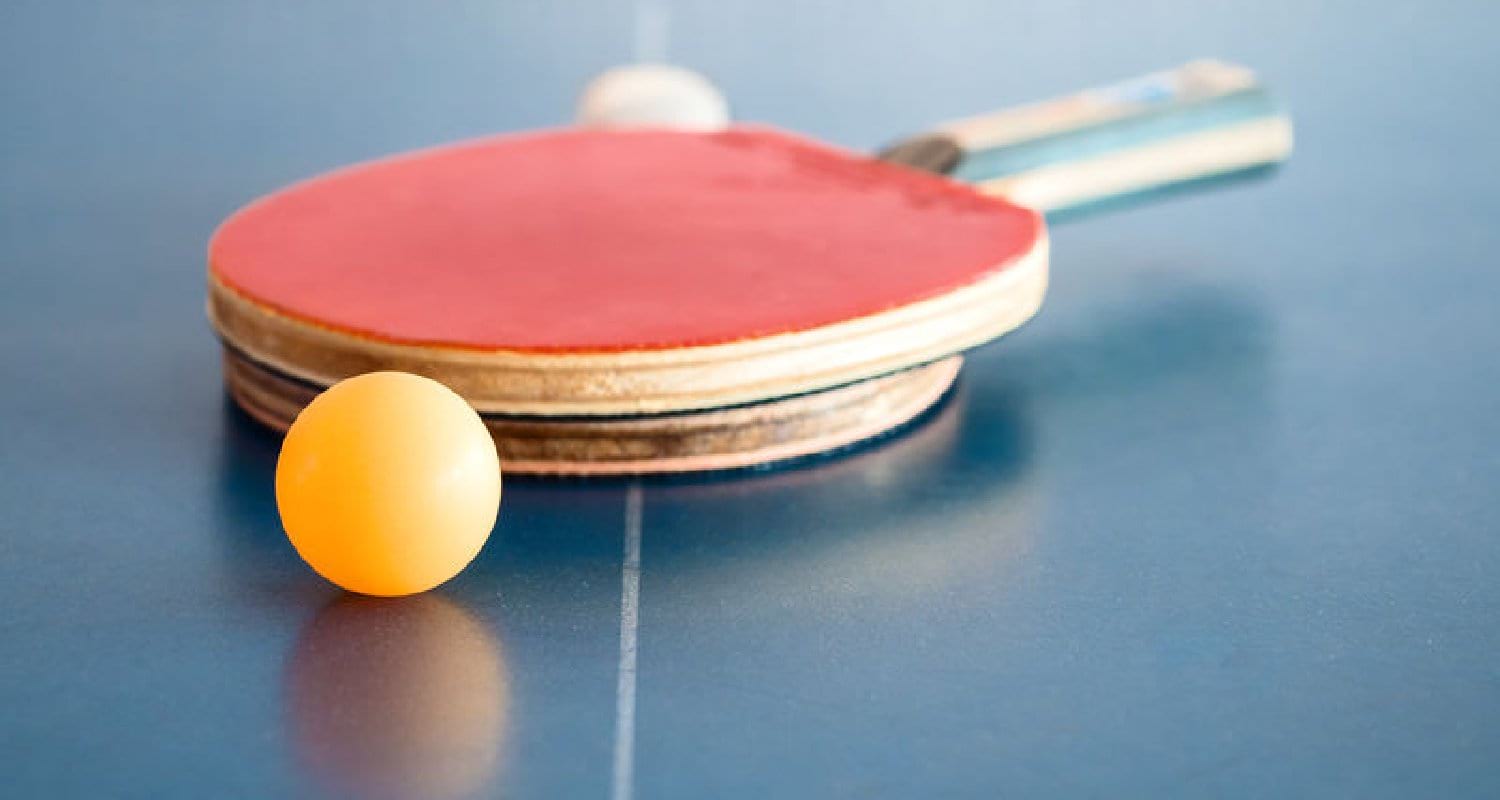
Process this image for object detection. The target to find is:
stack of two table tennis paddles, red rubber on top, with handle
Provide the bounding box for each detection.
[209,62,1290,474]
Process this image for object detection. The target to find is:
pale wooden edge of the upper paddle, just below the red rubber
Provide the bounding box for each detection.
[209,234,1049,416]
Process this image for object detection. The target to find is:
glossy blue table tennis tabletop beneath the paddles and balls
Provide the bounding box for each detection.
[0,0,1500,798]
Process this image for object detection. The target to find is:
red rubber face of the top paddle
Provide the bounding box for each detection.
[209,128,1043,353]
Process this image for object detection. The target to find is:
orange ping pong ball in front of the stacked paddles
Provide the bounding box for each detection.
[276,372,500,596]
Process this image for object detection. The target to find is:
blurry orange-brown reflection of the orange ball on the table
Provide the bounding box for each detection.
[285,593,510,800]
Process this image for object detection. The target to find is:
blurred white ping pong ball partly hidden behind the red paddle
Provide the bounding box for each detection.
[578,65,729,131]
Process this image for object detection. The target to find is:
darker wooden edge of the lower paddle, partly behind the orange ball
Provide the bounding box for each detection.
[224,347,963,476]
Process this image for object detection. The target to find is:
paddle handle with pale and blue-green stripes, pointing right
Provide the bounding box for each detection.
[881,60,1292,215]
